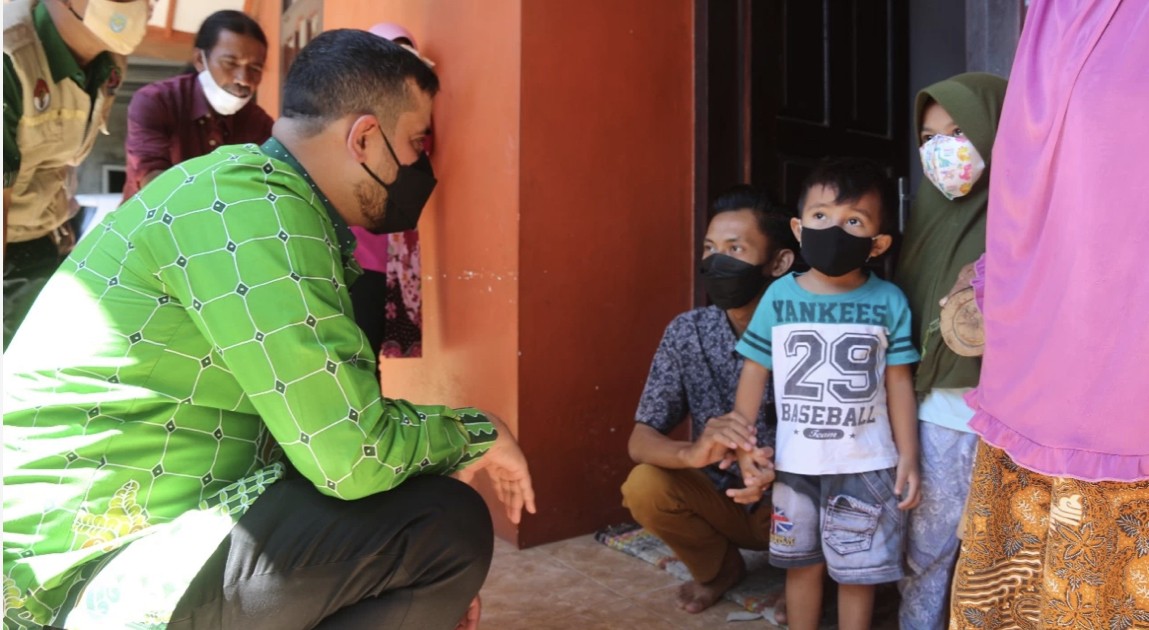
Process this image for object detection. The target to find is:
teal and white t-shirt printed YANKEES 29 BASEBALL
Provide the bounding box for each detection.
[738,274,919,475]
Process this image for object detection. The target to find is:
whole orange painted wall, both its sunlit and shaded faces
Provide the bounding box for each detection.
[253,0,694,546]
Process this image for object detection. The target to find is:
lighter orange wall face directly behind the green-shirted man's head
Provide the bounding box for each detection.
[324,0,520,540]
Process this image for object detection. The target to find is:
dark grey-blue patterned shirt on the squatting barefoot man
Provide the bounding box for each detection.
[634,306,777,491]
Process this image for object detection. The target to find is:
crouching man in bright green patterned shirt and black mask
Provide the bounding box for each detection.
[3,30,534,629]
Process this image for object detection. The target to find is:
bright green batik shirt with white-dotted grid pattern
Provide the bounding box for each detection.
[3,139,495,628]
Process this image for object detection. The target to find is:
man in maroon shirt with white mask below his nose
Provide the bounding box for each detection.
[124,10,272,200]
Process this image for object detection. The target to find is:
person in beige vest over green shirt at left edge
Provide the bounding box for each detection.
[3,0,151,348]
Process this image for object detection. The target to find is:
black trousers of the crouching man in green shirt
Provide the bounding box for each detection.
[168,476,494,630]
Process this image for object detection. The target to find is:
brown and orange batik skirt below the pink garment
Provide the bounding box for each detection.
[950,443,1149,630]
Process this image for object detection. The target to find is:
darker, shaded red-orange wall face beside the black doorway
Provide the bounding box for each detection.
[519,0,694,546]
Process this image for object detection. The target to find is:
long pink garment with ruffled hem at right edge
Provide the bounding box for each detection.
[970,0,1149,482]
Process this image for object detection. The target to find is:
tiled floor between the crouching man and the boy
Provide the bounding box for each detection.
[481,535,897,630]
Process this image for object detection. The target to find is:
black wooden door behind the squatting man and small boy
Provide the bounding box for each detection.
[696,0,910,213]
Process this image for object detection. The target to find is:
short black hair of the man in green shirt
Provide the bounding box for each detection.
[283,29,439,133]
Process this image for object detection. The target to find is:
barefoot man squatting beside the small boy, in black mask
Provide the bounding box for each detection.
[623,186,797,613]
